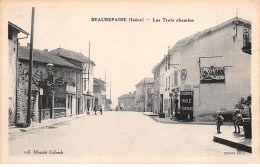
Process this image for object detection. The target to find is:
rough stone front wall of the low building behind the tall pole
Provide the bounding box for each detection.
[17,59,76,123]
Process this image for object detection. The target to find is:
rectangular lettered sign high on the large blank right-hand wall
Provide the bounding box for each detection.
[200,66,225,83]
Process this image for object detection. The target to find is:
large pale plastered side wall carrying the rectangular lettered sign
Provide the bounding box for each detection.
[181,24,251,115]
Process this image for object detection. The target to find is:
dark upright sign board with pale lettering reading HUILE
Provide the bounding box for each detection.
[180,91,193,112]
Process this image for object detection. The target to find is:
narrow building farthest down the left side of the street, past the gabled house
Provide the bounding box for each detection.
[94,78,106,110]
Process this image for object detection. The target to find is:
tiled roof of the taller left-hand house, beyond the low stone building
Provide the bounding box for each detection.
[48,48,96,66]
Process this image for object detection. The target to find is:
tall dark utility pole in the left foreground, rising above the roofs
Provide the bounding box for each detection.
[26,7,35,127]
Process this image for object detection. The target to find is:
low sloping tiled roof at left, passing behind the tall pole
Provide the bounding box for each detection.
[18,46,78,68]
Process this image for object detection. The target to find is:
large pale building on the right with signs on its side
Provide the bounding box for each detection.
[153,18,251,120]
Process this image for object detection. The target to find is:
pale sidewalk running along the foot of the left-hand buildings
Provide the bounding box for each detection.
[8,113,87,135]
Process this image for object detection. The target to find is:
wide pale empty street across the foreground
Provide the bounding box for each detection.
[9,111,247,157]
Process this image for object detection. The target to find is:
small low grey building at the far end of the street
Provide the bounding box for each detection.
[118,92,136,111]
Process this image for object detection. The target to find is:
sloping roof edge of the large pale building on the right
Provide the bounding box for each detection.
[155,17,251,66]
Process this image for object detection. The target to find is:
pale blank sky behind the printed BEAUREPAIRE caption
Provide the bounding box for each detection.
[4,1,256,107]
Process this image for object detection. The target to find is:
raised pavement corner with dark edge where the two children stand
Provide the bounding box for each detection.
[213,126,252,153]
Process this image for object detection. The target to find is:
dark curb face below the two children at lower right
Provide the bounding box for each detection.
[213,135,252,153]
